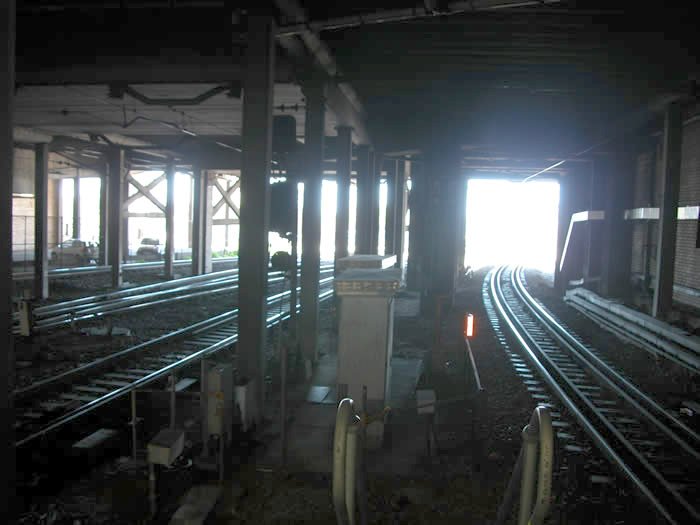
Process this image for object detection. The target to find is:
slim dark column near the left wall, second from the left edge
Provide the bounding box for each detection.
[34,144,49,299]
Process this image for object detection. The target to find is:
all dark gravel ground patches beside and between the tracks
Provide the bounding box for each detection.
[23,271,688,525]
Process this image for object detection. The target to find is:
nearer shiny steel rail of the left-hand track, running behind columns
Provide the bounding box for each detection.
[15,277,333,448]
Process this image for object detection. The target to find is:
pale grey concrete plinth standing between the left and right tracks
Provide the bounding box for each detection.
[335,269,401,448]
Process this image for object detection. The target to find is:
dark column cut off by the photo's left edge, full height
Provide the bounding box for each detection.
[0,0,15,522]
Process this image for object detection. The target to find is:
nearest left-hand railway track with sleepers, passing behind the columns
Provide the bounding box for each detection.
[13,276,333,447]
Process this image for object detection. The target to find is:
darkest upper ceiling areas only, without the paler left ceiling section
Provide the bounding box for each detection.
[12,0,700,161]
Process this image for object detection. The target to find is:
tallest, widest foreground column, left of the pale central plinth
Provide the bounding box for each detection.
[238,10,276,422]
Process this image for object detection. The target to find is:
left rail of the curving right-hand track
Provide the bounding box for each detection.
[490,267,681,525]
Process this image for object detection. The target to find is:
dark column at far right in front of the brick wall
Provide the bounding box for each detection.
[652,102,682,318]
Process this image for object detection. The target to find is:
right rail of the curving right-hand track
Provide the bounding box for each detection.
[512,267,700,452]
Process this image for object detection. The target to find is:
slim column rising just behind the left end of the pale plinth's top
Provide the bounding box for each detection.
[335,126,352,261]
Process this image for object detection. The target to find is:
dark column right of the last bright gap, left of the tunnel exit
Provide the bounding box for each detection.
[406,162,428,291]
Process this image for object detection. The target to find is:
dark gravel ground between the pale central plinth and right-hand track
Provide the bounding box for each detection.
[198,272,535,524]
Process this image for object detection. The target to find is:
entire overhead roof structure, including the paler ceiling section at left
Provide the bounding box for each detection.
[10,0,697,168]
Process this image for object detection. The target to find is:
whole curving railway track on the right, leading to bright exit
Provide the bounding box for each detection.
[489,267,700,525]
